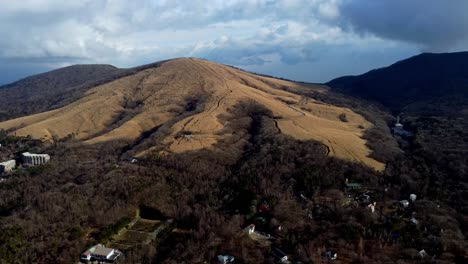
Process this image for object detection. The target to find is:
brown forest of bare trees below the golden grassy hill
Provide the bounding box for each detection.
[0,99,467,263]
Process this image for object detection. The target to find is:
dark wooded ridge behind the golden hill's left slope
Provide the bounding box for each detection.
[0,62,171,121]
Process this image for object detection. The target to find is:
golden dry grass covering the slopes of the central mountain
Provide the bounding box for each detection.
[0,59,384,170]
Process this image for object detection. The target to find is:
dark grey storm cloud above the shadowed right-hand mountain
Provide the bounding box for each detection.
[340,0,468,51]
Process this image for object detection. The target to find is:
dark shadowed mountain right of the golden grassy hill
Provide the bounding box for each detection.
[327,52,468,115]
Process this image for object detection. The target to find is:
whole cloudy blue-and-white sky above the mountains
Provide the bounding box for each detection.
[0,0,468,83]
